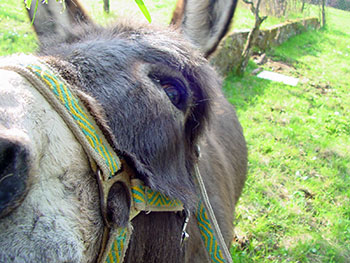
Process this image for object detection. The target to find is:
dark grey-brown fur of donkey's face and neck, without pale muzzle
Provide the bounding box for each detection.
[0,1,247,263]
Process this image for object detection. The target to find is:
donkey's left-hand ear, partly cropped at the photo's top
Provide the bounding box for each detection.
[28,0,92,42]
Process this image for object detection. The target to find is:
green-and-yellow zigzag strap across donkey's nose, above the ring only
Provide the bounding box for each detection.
[24,61,121,180]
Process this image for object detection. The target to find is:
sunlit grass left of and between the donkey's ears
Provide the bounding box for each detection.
[0,0,175,56]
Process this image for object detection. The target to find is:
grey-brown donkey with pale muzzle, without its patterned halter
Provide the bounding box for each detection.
[0,0,247,263]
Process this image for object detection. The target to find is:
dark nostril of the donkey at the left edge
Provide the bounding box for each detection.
[0,138,28,217]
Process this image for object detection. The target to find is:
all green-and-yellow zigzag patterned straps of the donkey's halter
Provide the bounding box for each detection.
[3,57,228,263]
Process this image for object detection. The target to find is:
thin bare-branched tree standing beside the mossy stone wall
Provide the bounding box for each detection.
[236,0,267,76]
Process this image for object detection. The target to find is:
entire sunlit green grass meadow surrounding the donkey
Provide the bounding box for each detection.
[0,0,350,263]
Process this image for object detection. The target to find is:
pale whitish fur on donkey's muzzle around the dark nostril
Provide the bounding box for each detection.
[0,66,102,262]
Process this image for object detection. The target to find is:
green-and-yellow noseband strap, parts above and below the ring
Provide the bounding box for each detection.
[1,59,131,263]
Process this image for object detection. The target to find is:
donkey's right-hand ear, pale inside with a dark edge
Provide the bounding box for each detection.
[171,0,237,57]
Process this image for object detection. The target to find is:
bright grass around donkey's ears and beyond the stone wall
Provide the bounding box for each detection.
[0,0,324,56]
